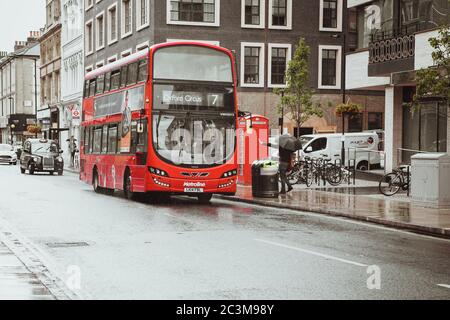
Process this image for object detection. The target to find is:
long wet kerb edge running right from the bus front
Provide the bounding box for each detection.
[214,195,450,239]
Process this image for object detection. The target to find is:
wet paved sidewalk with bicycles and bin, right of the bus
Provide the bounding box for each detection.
[217,182,450,238]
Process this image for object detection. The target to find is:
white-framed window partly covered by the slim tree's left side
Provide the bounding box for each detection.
[269,44,291,88]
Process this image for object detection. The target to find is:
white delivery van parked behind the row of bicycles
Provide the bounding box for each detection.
[300,132,380,170]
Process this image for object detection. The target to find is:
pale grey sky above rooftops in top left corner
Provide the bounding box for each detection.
[0,0,45,52]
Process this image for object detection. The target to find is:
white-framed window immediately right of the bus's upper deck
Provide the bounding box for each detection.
[241,43,264,87]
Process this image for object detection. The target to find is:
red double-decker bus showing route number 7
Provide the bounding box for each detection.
[80,42,237,202]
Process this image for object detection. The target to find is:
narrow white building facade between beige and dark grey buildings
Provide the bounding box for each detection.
[60,0,84,166]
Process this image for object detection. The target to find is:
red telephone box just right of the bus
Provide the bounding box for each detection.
[237,115,269,186]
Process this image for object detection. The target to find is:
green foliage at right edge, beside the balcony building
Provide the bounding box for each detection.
[413,26,450,105]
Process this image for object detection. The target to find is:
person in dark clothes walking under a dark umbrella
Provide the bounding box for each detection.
[262,134,302,194]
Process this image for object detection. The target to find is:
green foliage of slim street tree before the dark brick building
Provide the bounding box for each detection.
[274,38,323,127]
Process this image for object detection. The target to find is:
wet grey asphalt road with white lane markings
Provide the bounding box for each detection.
[0,166,450,299]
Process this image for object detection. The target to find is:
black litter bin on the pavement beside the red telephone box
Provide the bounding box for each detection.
[252,160,279,198]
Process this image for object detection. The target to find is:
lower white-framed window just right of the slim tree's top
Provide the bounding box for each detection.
[319,46,341,89]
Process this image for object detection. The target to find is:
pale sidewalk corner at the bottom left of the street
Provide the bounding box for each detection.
[0,241,55,300]
